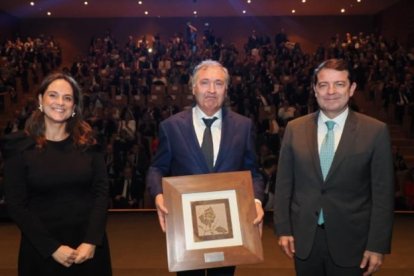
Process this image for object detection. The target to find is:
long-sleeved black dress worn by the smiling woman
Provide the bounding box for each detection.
[2,133,112,276]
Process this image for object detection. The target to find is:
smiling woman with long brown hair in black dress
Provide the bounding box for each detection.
[2,73,112,276]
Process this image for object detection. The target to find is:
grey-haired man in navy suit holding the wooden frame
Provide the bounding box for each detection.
[147,60,264,275]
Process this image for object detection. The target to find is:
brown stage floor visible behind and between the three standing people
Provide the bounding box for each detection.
[0,211,414,276]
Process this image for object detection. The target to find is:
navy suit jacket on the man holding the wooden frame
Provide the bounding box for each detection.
[147,108,263,200]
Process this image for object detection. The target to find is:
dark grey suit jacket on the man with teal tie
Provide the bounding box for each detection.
[274,110,394,266]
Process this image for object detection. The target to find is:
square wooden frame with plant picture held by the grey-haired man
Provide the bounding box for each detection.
[162,171,263,272]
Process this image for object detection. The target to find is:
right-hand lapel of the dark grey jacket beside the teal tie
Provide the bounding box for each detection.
[326,110,357,180]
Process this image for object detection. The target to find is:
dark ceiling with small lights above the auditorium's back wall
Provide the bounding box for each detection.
[0,0,399,18]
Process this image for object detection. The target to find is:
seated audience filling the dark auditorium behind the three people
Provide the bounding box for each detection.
[0,26,414,209]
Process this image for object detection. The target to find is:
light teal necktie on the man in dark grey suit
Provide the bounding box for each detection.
[318,121,335,225]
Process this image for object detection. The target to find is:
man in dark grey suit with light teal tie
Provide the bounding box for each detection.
[274,59,394,276]
